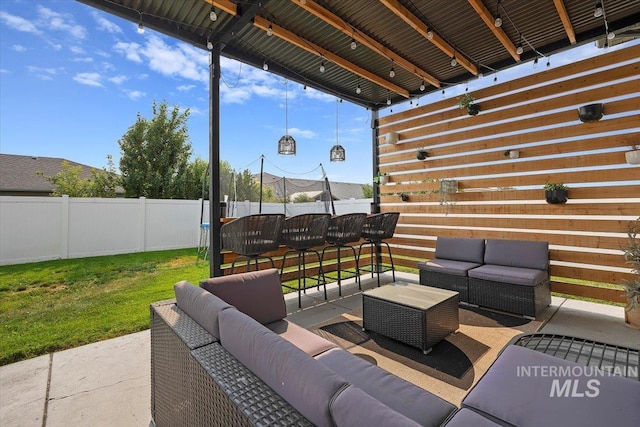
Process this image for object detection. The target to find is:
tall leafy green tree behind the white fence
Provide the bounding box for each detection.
[118,101,191,199]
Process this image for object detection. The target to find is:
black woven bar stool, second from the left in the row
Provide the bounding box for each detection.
[280,213,331,308]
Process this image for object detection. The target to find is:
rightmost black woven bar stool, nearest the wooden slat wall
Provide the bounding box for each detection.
[358,212,400,286]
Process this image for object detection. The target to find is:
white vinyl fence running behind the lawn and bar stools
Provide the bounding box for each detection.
[0,196,372,265]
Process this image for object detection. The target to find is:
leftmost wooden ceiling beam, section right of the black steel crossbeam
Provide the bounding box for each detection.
[253,16,409,98]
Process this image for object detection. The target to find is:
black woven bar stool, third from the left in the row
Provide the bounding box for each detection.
[320,213,367,296]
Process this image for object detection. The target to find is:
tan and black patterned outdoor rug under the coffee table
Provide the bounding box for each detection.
[310,307,551,405]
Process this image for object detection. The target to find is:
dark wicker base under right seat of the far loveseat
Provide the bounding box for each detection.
[469,277,551,318]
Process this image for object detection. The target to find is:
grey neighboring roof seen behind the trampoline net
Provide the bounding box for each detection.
[254,173,362,200]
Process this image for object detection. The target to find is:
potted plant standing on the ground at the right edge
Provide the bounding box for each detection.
[622,218,640,329]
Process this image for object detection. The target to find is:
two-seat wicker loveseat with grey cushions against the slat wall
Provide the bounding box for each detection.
[418,237,551,318]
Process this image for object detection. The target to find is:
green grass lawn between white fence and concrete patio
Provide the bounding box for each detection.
[0,249,209,365]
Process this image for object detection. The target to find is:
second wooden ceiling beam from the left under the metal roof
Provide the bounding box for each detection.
[292,0,440,87]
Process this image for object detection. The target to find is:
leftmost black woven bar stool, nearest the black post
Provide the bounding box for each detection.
[220,214,284,274]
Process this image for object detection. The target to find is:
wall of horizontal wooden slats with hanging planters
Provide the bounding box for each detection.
[378,45,640,301]
